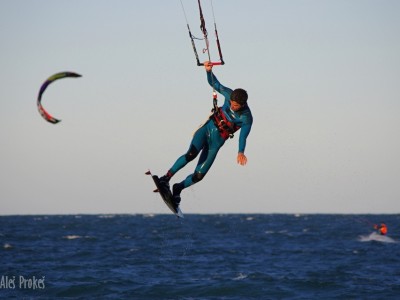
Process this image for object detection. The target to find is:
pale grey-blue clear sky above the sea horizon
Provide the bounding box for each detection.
[0,0,400,215]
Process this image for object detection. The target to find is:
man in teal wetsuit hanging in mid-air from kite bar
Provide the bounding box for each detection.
[160,61,253,205]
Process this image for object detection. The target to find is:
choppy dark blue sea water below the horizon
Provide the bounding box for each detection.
[0,214,400,299]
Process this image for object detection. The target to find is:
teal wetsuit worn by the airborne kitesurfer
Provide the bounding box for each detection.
[168,72,253,189]
